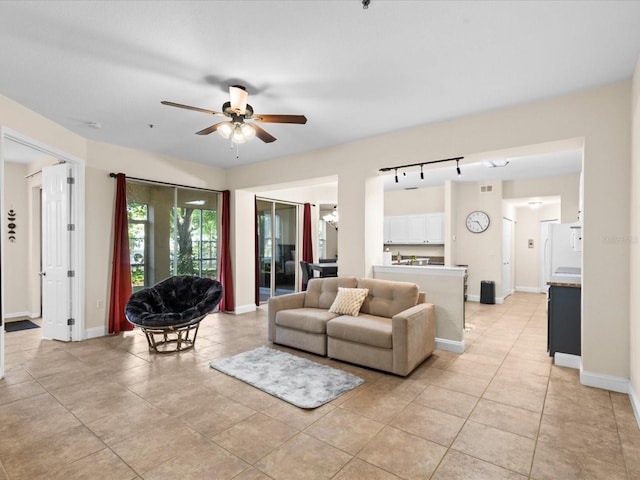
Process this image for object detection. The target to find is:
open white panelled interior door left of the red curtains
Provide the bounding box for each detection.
[42,164,73,341]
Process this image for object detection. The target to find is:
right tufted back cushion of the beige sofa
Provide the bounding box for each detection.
[358,278,419,318]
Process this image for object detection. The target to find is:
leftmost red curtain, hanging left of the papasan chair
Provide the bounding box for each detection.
[109,173,133,333]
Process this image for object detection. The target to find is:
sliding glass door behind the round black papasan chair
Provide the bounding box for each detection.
[127,180,220,291]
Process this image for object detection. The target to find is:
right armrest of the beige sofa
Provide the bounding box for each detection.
[391,303,436,376]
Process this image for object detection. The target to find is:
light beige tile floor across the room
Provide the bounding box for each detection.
[0,294,640,480]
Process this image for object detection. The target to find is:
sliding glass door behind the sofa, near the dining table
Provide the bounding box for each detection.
[256,199,298,302]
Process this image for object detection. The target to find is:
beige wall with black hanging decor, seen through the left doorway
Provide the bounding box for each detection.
[1,163,31,317]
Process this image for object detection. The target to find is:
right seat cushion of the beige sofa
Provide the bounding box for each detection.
[327,313,393,348]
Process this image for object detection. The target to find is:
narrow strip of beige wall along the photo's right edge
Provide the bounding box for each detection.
[628,60,640,412]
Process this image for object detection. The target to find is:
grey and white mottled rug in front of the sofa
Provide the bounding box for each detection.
[209,347,364,408]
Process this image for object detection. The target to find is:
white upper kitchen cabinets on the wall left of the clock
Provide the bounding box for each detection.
[384,213,444,245]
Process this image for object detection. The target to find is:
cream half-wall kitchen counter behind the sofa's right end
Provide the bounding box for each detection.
[373,264,467,353]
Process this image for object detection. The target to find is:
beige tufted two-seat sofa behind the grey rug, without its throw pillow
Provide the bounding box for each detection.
[269,277,435,376]
